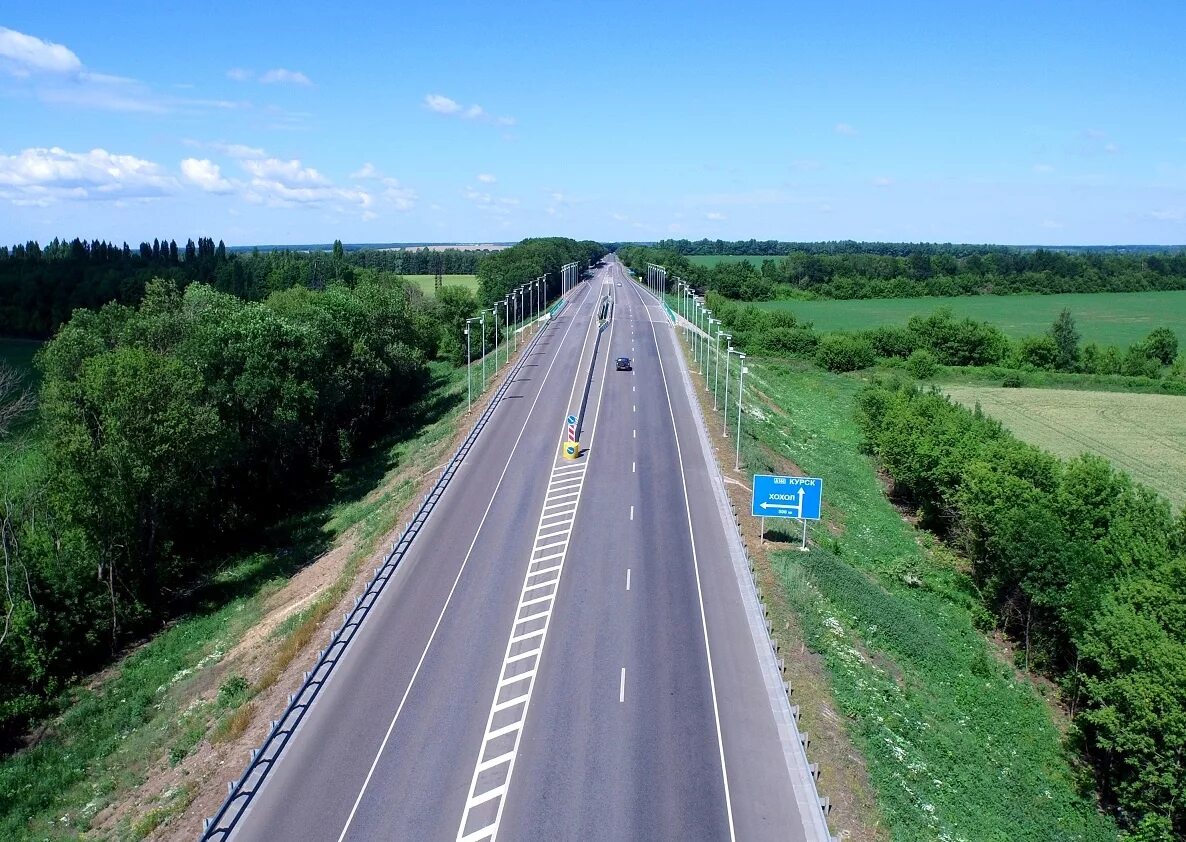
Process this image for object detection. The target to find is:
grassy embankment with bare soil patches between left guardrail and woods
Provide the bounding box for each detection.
[0,364,479,840]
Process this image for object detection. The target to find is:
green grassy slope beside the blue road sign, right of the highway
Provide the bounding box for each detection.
[742,361,1116,842]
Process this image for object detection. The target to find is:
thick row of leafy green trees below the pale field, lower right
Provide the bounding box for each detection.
[859,382,1186,842]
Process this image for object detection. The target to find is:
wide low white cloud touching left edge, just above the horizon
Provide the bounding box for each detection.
[0,146,177,205]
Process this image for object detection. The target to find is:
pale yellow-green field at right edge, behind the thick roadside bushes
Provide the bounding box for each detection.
[944,385,1186,509]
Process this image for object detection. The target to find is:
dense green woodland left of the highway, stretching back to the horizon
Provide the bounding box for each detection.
[0,233,604,745]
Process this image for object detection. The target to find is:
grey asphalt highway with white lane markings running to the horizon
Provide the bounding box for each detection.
[224,257,827,842]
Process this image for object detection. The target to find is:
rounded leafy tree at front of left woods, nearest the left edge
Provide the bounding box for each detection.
[44,347,223,618]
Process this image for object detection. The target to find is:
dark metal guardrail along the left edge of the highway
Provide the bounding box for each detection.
[199,313,557,842]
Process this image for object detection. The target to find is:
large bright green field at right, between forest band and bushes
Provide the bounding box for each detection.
[758,291,1186,346]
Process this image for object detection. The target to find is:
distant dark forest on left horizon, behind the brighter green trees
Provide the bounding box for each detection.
[0,237,486,338]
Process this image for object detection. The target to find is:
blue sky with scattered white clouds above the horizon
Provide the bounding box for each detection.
[0,0,1186,244]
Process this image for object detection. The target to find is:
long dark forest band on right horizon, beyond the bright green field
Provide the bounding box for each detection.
[619,243,1186,301]
